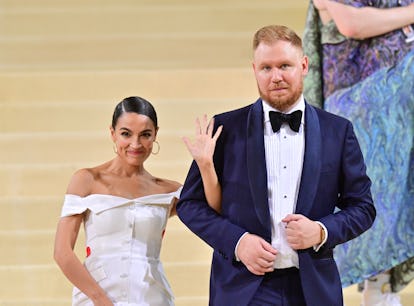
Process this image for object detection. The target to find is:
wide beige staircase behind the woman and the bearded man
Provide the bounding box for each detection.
[0,0,410,306]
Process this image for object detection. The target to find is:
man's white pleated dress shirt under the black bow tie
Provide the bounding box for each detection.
[262,96,305,269]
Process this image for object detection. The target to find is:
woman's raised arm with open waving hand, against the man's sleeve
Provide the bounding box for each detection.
[183,115,223,213]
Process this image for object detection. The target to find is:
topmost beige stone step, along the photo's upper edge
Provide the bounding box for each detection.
[0,0,307,40]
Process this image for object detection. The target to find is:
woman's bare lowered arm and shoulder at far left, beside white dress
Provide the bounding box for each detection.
[54,170,113,306]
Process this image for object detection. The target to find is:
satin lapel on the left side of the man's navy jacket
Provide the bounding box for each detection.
[246,99,270,229]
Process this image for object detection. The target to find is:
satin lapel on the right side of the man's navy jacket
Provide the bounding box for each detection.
[296,103,321,216]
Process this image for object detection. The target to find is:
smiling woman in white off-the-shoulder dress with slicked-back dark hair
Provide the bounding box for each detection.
[54,97,219,306]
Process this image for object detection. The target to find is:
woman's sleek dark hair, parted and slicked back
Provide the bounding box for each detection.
[112,97,158,129]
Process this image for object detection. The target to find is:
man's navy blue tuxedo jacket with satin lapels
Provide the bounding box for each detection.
[177,99,376,306]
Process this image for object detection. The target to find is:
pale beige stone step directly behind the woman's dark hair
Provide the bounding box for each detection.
[0,97,244,132]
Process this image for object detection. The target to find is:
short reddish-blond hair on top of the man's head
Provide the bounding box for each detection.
[253,25,302,50]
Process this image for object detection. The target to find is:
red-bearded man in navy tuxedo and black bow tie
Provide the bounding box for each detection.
[177,26,375,306]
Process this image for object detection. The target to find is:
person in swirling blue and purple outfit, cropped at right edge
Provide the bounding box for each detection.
[304,0,414,305]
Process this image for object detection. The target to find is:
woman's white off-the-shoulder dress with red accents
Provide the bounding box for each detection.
[61,189,180,306]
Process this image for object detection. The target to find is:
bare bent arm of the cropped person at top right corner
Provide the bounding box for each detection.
[313,0,414,39]
